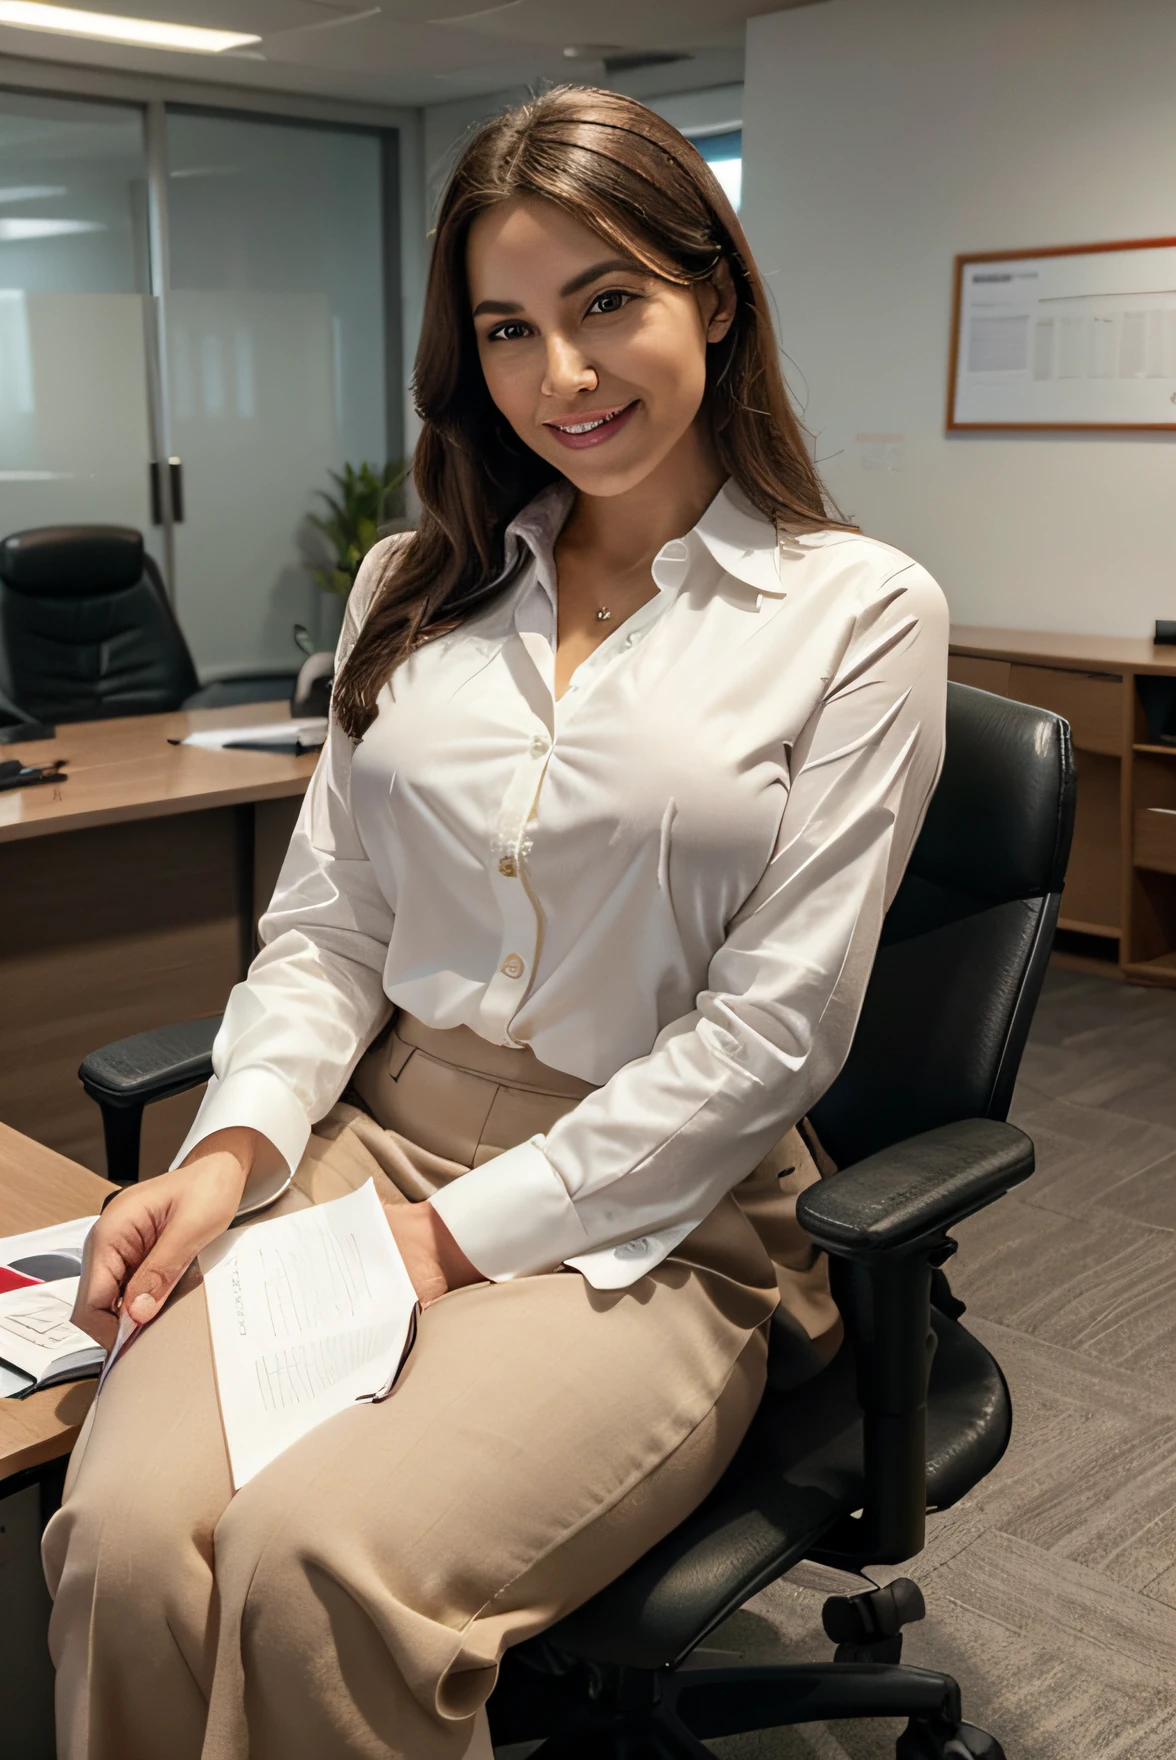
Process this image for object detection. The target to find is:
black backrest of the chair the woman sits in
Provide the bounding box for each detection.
[813,685,1074,1167]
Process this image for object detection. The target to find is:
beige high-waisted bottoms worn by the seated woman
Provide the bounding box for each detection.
[44,1016,809,1760]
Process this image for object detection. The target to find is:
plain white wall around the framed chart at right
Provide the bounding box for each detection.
[743,0,1176,635]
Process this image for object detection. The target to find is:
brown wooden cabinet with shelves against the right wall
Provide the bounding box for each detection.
[949,627,1176,986]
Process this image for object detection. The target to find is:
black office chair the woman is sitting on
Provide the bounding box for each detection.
[81,685,1074,1760]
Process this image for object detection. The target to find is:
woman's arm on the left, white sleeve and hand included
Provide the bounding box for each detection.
[76,540,404,1346]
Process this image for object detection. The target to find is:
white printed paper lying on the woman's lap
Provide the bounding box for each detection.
[199,1181,417,1491]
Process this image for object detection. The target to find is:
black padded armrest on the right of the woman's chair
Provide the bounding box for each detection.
[796,1118,1033,1260]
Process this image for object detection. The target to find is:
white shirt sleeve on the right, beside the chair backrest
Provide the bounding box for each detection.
[433,563,947,1287]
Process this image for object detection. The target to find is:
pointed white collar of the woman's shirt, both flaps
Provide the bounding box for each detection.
[505,477,785,604]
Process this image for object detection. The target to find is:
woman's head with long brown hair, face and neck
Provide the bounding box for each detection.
[334,88,838,737]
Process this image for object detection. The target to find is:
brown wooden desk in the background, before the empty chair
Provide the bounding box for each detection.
[0,704,315,1170]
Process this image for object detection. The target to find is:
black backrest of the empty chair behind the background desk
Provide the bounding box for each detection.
[0,526,199,722]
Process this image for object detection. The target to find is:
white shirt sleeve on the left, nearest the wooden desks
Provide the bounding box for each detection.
[176,540,394,1177]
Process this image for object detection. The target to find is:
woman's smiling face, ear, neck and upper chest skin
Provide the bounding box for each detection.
[467,197,736,679]
